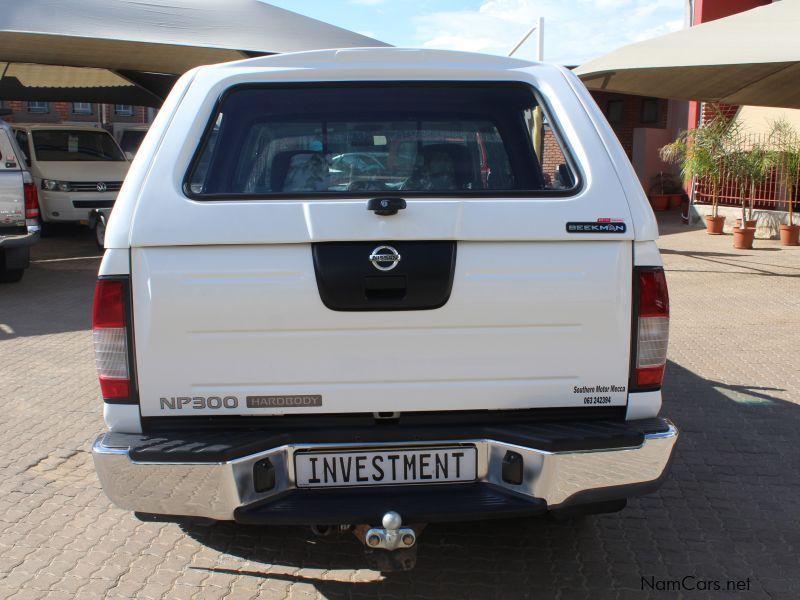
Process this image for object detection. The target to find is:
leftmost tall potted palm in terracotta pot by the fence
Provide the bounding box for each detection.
[659,115,729,235]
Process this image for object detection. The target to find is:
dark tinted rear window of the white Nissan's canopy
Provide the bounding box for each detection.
[186,83,576,199]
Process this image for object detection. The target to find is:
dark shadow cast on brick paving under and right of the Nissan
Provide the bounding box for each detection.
[184,362,800,599]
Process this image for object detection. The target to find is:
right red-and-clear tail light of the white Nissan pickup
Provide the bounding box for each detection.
[631,267,669,391]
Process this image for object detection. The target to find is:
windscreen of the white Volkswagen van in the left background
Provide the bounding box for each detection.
[32,129,125,161]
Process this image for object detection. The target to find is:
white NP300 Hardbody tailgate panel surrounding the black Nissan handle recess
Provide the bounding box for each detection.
[132,236,632,415]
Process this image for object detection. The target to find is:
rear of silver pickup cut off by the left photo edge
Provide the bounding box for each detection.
[0,123,39,283]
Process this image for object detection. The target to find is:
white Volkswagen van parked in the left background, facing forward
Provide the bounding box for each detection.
[14,124,130,234]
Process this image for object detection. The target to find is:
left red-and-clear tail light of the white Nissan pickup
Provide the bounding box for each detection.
[92,279,131,401]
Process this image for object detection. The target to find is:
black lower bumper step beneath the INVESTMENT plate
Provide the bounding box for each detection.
[234,483,547,525]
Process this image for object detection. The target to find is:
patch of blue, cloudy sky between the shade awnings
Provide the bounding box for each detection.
[266,0,685,65]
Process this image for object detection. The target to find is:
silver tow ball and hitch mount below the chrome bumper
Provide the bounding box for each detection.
[354,510,424,572]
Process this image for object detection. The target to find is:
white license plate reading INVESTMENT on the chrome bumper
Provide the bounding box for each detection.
[294,446,478,487]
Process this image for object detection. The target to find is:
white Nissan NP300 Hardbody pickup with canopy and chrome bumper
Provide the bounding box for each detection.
[93,48,678,568]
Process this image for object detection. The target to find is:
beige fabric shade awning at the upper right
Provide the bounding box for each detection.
[575,0,800,108]
